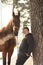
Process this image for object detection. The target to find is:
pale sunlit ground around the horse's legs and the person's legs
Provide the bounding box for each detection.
[0,48,33,65]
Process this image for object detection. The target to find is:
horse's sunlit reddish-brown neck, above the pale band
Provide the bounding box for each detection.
[0,17,14,38]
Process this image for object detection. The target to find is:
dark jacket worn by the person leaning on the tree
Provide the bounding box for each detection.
[19,33,34,54]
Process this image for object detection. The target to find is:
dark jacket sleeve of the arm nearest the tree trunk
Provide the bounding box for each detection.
[27,34,34,54]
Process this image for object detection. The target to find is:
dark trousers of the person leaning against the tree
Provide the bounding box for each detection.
[16,54,29,65]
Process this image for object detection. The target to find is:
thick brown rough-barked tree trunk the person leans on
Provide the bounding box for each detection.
[30,0,43,65]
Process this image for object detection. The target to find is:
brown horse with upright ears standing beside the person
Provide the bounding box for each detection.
[0,12,20,65]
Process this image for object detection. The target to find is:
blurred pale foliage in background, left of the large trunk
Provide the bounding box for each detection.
[1,0,31,27]
